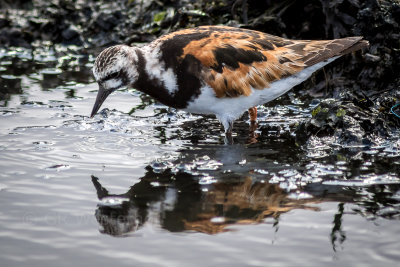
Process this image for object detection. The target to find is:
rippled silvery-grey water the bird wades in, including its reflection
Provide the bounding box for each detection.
[0,48,400,266]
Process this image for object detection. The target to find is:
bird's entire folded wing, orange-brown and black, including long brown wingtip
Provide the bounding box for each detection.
[177,26,368,97]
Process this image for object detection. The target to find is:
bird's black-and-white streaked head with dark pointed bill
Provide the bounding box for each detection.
[90,45,138,117]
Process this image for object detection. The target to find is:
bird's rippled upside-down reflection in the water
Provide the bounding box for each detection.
[92,168,316,236]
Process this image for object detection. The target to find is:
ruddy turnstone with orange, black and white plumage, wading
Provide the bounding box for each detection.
[91,26,368,135]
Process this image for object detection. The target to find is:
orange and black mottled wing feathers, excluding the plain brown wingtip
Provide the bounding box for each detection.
[177,27,305,97]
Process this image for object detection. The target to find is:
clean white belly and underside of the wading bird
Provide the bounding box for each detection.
[185,57,338,129]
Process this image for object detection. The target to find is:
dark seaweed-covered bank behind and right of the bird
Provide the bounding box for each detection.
[0,0,400,144]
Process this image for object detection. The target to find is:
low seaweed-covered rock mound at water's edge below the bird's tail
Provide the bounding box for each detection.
[296,90,400,145]
